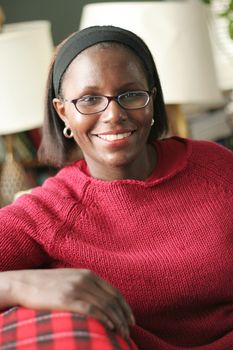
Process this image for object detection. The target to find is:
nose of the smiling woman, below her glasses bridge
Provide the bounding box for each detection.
[101,100,127,124]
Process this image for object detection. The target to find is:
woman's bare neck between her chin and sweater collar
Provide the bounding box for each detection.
[85,144,156,181]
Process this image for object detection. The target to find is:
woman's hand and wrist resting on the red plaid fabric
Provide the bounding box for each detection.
[4,269,135,337]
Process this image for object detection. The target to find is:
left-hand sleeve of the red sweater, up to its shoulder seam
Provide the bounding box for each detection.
[0,165,86,271]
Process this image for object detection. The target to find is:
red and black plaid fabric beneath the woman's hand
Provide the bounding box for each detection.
[0,307,137,350]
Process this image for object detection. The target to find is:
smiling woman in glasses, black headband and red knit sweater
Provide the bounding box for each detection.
[0,26,233,350]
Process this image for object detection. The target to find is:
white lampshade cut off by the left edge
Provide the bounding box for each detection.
[0,21,53,135]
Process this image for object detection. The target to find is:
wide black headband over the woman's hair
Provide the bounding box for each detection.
[53,26,155,97]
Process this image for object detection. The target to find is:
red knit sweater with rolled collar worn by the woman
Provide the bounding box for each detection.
[0,138,233,350]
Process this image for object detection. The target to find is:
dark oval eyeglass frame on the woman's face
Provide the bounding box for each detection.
[59,87,157,115]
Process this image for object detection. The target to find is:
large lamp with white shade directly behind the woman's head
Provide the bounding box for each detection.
[80,0,222,136]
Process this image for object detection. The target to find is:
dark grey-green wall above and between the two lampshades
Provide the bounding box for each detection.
[0,0,164,45]
